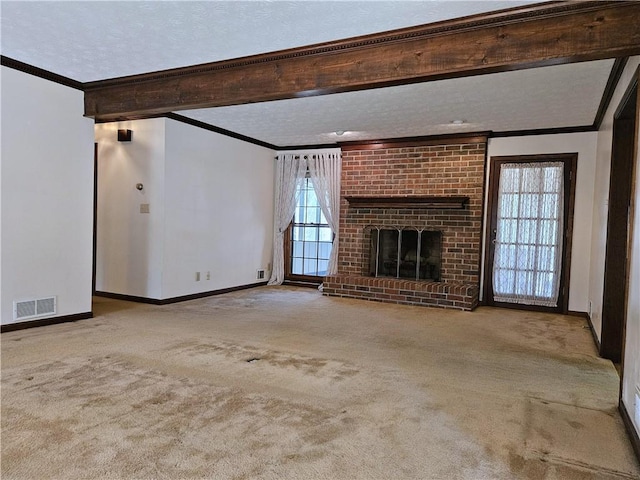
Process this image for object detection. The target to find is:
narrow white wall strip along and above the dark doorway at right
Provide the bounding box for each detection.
[589,56,640,338]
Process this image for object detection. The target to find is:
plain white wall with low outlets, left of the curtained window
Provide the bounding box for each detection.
[163,120,275,298]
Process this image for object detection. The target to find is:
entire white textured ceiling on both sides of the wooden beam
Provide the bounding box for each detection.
[0,0,613,146]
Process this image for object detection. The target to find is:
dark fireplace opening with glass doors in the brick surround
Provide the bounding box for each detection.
[369,227,442,282]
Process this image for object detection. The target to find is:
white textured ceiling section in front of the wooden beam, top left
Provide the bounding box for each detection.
[0,0,532,82]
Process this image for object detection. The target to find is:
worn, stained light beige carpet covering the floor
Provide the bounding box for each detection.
[1,287,640,480]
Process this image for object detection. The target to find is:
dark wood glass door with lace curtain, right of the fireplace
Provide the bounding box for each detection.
[484,153,577,313]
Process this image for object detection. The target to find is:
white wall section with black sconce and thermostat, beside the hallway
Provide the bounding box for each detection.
[95,118,165,299]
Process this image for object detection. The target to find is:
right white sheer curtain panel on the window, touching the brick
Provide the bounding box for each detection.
[308,152,342,275]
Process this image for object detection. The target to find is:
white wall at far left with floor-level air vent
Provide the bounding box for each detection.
[0,67,93,324]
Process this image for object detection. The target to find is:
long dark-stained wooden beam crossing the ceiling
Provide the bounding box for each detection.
[85,1,640,121]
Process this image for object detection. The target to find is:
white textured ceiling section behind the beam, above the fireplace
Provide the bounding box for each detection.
[178,60,613,146]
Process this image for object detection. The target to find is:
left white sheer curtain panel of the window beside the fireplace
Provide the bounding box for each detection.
[269,153,307,285]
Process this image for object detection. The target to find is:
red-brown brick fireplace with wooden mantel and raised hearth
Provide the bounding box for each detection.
[323,136,487,310]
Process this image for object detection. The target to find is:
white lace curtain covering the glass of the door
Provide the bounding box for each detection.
[493,162,564,307]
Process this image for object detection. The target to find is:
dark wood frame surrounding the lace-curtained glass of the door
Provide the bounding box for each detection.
[482,153,578,314]
